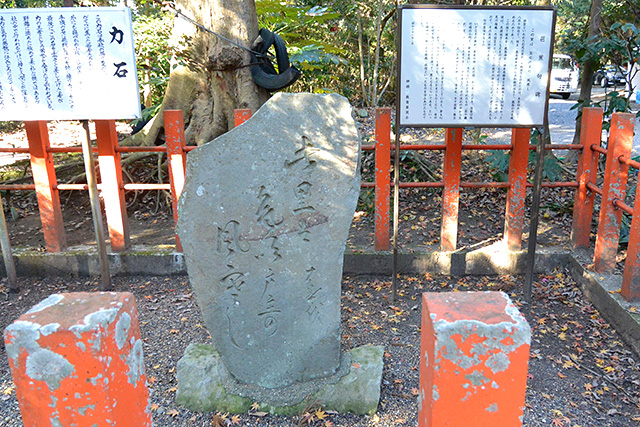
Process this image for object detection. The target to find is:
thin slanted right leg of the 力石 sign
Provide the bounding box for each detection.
[82,120,111,291]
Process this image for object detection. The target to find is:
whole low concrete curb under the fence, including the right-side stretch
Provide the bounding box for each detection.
[0,243,640,355]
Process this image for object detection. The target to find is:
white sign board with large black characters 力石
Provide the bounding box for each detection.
[0,7,140,120]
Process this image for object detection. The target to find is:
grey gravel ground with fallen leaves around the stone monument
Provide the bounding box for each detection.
[0,271,640,427]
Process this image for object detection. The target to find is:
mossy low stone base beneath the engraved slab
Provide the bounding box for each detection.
[176,344,384,415]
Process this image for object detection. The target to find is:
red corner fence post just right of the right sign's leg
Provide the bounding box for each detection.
[571,108,602,249]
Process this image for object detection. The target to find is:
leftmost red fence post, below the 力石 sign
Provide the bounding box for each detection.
[24,121,67,252]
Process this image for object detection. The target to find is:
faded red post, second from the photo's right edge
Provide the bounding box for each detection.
[594,113,635,273]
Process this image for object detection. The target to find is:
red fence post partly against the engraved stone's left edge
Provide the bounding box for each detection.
[164,110,187,252]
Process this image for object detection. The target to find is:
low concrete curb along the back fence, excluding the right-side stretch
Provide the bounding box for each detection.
[0,243,571,277]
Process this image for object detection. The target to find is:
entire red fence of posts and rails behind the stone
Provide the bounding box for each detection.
[0,108,640,299]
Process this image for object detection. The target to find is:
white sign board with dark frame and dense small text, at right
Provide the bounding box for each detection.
[398,6,555,127]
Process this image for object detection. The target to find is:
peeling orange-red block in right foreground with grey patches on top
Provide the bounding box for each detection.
[418,292,531,427]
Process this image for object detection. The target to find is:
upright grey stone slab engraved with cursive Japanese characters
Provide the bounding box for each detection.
[177,94,360,388]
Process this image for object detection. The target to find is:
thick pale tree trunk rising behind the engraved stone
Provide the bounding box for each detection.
[143,0,269,145]
